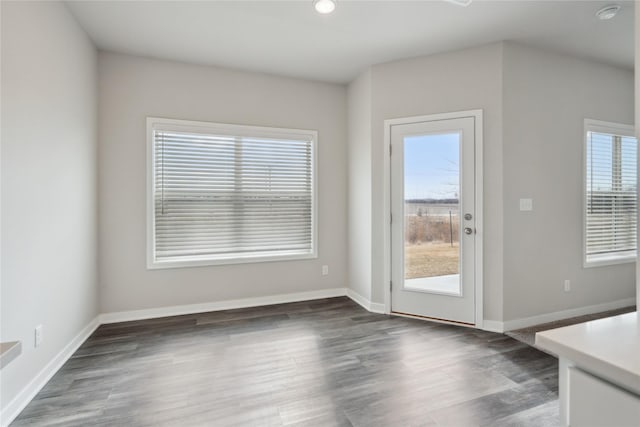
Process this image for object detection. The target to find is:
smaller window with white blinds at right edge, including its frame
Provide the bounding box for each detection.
[585,120,638,266]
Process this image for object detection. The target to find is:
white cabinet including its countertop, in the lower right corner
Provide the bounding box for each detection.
[536,312,640,427]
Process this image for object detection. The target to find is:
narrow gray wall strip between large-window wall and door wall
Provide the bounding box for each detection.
[348,70,372,300]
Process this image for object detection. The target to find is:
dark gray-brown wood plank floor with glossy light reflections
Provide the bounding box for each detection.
[12,298,558,427]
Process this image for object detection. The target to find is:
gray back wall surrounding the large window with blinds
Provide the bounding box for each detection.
[99,53,347,312]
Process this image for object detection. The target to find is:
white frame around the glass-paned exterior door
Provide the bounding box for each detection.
[383,110,484,329]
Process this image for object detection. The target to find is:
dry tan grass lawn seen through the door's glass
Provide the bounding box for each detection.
[404,242,459,279]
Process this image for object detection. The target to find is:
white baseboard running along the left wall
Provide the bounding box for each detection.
[0,316,100,427]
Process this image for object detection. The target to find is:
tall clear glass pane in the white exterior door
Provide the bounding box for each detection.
[403,133,461,295]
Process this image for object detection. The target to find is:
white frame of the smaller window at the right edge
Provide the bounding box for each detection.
[582,119,640,268]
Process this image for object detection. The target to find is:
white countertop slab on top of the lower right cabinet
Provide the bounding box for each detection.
[536,312,640,394]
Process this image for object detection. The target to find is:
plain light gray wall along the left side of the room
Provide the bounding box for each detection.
[0,2,98,416]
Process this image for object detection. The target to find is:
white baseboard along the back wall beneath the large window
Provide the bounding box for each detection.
[100,288,347,324]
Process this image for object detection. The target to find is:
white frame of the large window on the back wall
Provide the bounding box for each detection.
[146,117,318,270]
